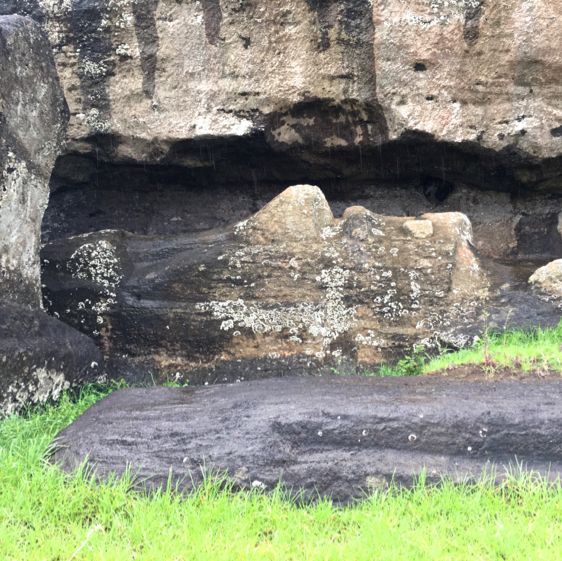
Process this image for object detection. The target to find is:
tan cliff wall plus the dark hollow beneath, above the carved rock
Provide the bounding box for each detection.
[0,0,562,308]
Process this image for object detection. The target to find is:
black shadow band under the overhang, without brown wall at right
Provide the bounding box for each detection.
[44,131,562,247]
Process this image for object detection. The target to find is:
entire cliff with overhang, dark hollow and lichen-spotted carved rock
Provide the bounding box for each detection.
[0,0,562,394]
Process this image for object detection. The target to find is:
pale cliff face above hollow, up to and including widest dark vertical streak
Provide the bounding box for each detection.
[5,0,385,167]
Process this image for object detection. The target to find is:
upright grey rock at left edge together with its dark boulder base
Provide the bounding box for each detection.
[0,16,101,415]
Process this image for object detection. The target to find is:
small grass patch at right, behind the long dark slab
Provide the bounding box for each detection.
[422,321,562,373]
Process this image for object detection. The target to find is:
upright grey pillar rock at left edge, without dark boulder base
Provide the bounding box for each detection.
[0,16,68,306]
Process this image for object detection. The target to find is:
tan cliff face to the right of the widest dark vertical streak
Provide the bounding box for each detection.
[373,0,562,179]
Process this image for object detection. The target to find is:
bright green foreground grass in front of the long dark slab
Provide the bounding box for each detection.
[0,388,562,561]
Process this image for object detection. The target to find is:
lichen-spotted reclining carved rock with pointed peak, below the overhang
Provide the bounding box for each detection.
[43,185,487,382]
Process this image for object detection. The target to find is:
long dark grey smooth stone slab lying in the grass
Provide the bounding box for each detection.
[53,377,562,501]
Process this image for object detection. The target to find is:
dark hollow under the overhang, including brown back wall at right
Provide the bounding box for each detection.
[43,133,562,260]
